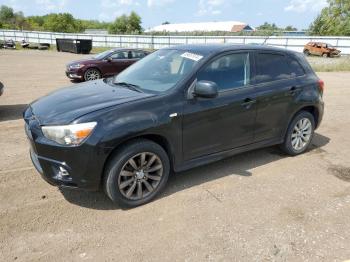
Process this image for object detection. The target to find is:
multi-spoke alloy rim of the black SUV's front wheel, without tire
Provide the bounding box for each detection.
[118,152,163,200]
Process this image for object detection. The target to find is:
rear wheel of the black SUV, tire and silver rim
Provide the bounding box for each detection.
[280,111,315,156]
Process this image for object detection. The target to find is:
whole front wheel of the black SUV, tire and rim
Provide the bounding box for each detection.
[104,139,170,207]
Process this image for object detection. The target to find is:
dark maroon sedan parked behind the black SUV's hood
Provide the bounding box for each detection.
[66,49,149,81]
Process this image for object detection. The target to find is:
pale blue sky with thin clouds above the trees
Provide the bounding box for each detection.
[0,0,327,29]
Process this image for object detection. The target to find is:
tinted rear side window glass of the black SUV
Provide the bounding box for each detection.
[256,54,304,83]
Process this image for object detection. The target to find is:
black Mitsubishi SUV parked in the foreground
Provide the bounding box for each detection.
[24,45,324,209]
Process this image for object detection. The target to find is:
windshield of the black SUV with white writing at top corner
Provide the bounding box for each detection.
[113,49,203,93]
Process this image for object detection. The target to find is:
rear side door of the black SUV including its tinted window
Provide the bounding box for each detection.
[254,51,305,142]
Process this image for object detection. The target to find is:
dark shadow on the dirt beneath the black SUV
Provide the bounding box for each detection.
[60,133,330,210]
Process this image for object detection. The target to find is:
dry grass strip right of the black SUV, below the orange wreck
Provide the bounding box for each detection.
[307,56,350,72]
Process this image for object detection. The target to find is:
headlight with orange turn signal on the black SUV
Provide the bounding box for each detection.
[41,122,97,145]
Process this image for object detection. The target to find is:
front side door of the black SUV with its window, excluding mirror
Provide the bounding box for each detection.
[183,52,256,160]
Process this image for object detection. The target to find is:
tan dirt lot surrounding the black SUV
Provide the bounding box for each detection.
[0,50,350,261]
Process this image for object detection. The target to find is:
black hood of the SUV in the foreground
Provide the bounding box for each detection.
[30,80,154,125]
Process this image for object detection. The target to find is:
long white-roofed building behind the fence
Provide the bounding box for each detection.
[146,21,255,32]
